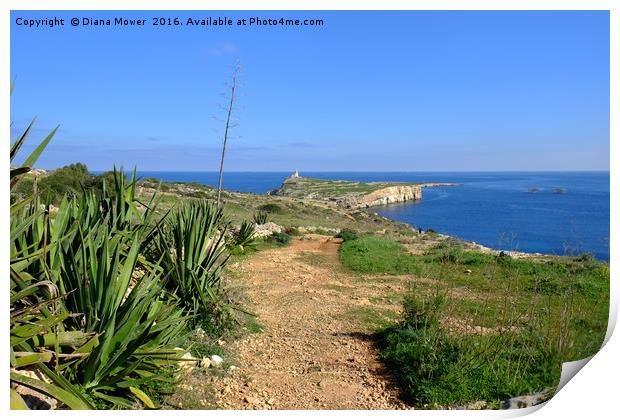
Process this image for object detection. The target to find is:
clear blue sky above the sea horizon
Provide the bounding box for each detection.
[11,11,609,171]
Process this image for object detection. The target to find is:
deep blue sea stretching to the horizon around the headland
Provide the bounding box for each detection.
[126,172,609,261]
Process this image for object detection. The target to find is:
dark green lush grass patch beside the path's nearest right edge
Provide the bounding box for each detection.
[378,314,561,408]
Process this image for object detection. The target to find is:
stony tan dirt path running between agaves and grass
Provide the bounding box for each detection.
[218,235,406,409]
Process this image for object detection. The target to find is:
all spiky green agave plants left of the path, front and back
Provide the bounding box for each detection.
[10,83,228,409]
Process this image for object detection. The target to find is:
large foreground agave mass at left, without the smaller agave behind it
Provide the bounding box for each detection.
[10,114,186,409]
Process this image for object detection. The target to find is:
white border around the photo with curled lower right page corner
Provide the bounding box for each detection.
[0,0,620,419]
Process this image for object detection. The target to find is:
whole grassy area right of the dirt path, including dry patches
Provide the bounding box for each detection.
[340,236,610,407]
